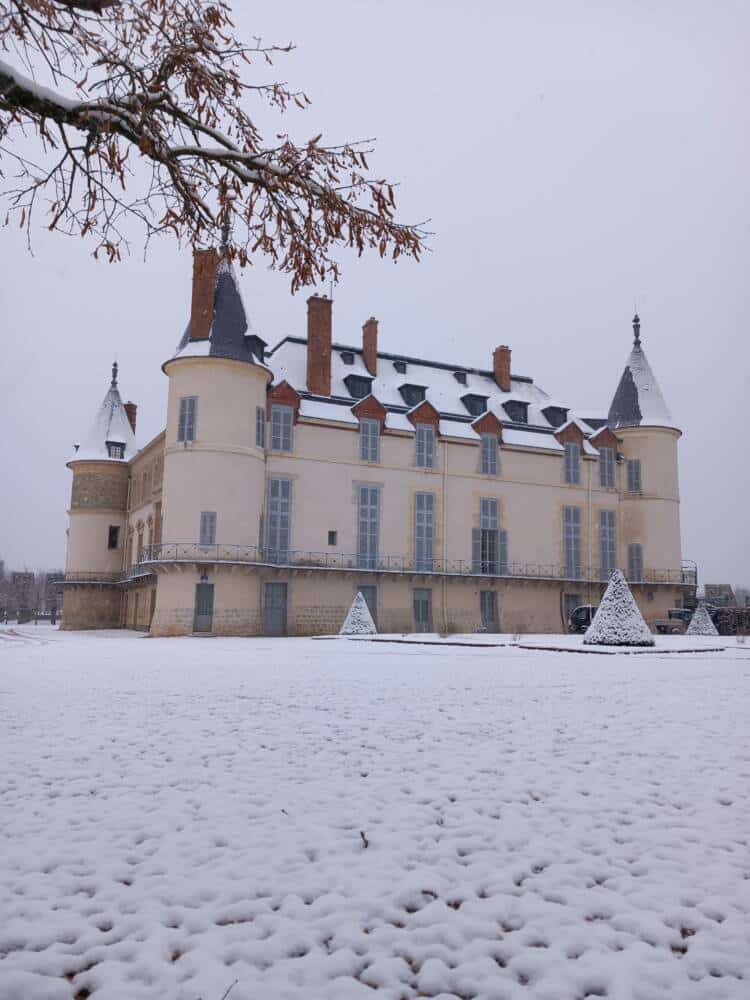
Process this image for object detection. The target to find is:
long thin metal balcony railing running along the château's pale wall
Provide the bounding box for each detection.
[131,542,695,586]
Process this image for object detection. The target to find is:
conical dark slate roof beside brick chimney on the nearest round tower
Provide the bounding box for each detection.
[173,258,266,364]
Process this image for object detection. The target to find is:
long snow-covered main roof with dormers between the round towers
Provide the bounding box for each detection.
[265,337,595,454]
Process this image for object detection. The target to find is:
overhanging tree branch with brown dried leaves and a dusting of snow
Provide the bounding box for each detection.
[0,0,426,289]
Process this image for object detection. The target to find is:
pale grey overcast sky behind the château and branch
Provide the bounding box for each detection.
[0,0,750,584]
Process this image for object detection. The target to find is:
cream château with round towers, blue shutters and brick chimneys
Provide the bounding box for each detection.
[63,250,696,635]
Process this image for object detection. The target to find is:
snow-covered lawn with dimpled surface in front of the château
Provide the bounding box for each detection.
[0,626,750,1000]
